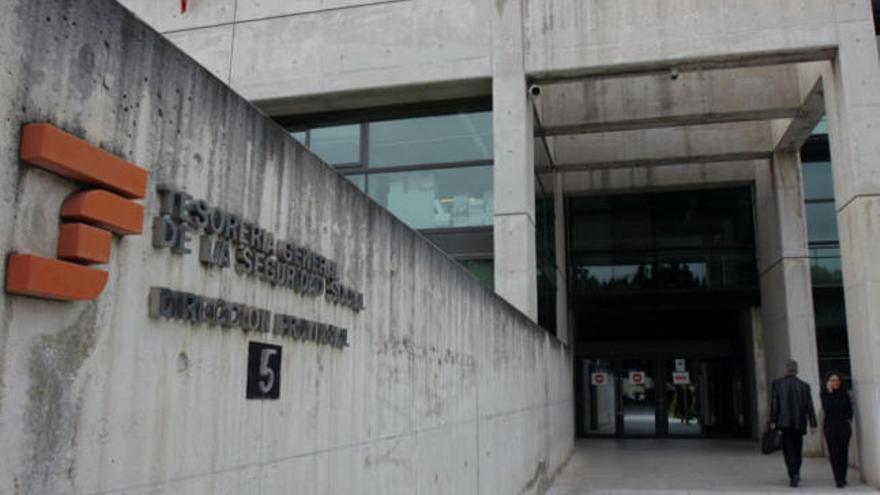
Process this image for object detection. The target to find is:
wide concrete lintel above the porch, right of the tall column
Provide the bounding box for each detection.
[525,0,838,81]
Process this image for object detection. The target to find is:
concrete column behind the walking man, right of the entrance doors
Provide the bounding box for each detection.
[755,152,822,455]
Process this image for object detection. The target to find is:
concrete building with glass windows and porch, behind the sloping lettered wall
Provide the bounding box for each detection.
[111,0,880,485]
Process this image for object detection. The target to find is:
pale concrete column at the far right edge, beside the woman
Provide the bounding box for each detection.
[824,0,880,486]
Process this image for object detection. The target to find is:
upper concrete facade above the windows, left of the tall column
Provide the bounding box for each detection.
[120,0,492,105]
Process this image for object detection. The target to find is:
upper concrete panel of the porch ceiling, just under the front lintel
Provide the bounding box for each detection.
[538,66,801,136]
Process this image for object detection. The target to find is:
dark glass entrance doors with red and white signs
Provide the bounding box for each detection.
[580,355,749,437]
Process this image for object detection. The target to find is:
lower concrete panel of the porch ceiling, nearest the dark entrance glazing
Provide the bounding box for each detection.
[539,122,773,171]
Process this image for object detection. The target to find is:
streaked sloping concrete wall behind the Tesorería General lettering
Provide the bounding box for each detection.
[0,0,574,495]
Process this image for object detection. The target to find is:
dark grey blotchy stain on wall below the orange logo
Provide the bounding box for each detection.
[23,303,97,493]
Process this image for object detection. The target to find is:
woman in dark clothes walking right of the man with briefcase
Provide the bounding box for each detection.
[822,372,853,488]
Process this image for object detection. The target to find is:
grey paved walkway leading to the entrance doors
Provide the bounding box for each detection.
[548,439,880,495]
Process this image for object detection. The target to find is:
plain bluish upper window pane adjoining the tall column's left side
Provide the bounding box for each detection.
[369,112,492,167]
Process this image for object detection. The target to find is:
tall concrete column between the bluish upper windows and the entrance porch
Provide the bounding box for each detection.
[492,0,538,321]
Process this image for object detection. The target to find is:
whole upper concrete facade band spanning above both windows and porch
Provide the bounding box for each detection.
[120,0,849,113]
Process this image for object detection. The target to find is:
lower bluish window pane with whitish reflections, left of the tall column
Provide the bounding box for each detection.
[367,166,495,229]
